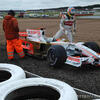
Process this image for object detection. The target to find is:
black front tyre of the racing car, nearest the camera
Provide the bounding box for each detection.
[47,45,67,67]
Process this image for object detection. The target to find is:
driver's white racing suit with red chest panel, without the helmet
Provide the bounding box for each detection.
[54,16,75,42]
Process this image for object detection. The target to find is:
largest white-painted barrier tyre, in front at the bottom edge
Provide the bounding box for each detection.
[0,78,78,100]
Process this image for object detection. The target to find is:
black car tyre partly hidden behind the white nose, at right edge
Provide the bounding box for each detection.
[84,42,100,53]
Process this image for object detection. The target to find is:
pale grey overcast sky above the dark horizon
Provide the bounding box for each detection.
[0,0,100,10]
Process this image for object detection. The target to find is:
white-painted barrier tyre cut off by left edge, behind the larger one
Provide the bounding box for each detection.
[0,63,26,87]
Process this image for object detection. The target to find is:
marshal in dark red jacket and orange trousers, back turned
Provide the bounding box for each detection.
[3,10,25,59]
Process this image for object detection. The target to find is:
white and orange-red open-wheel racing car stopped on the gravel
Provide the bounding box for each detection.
[20,28,100,67]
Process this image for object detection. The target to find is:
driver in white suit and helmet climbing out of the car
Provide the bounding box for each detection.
[53,7,76,42]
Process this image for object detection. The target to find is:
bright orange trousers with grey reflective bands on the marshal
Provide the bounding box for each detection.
[7,39,25,59]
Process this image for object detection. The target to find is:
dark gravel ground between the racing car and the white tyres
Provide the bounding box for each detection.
[0,45,100,94]
